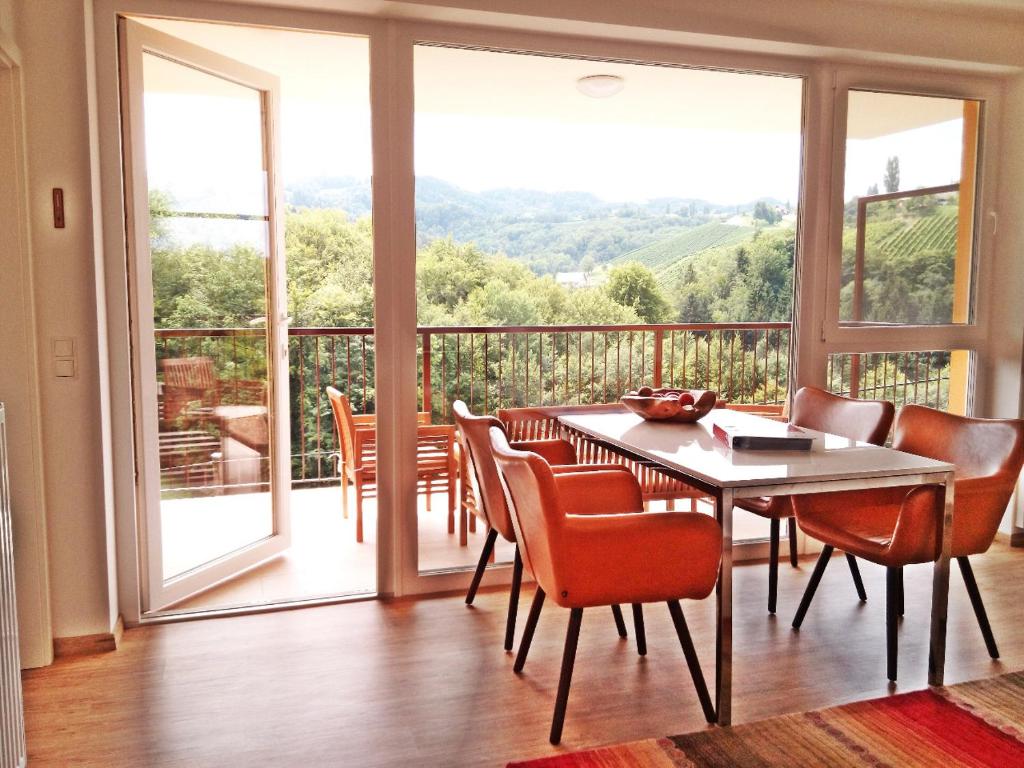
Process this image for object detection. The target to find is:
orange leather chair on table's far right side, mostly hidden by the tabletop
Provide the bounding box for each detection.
[736,387,896,613]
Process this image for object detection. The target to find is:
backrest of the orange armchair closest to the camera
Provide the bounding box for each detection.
[487,426,571,591]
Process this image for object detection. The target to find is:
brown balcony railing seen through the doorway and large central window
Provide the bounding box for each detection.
[157,323,790,483]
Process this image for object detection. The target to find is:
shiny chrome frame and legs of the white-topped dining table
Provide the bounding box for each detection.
[559,415,953,725]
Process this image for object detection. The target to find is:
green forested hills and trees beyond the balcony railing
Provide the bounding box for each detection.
[151,180,956,472]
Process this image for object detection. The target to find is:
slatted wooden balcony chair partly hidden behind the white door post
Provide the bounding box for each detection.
[327,387,459,543]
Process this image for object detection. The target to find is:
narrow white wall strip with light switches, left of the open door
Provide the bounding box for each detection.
[12,0,117,637]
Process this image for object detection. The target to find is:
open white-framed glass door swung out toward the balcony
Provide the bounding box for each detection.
[121,19,291,611]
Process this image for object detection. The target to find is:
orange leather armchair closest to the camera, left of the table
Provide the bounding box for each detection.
[490,427,722,744]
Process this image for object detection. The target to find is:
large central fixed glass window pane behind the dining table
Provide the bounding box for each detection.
[408,44,803,574]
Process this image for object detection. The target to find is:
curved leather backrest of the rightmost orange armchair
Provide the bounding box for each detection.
[893,406,1024,556]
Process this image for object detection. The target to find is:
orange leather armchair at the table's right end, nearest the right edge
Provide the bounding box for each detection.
[793,406,1024,681]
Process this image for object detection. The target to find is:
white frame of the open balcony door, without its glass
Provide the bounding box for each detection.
[118,17,291,613]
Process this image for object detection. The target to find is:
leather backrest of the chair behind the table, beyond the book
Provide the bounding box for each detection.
[790,387,896,445]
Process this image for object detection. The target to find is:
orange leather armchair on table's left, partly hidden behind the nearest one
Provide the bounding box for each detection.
[452,400,647,655]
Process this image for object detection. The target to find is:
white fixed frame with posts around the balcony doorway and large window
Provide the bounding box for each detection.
[93,0,1015,625]
